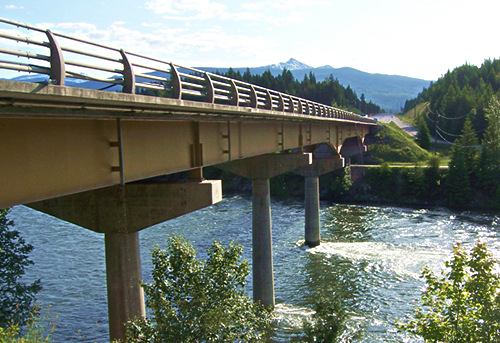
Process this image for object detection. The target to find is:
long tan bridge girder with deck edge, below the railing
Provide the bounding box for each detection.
[0,81,369,208]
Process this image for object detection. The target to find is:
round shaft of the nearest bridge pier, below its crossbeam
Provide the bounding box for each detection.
[104,232,146,342]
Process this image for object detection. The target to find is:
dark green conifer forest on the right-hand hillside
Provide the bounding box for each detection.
[405,59,500,209]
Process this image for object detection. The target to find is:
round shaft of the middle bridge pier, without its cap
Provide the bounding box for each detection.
[252,179,274,308]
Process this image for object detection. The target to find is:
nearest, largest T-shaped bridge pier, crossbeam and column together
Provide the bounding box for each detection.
[26,181,222,342]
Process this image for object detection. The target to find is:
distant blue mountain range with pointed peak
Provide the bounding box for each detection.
[196,58,430,112]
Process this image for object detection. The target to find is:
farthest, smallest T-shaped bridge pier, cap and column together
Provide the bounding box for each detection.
[294,156,344,247]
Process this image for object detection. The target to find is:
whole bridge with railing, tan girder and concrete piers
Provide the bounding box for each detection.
[0,18,376,340]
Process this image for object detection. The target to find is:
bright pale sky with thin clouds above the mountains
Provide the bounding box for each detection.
[0,0,500,80]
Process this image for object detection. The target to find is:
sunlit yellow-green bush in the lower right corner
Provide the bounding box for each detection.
[396,243,500,343]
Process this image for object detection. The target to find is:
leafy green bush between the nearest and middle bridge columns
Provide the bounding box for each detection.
[127,236,271,343]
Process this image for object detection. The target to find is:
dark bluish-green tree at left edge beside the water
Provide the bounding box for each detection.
[0,209,42,328]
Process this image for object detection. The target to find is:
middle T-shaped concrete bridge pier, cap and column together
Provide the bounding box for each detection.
[217,153,312,308]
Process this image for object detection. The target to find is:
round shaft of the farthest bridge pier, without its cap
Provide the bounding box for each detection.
[305,175,321,247]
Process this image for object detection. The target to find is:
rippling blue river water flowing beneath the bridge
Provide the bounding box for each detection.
[10,196,500,343]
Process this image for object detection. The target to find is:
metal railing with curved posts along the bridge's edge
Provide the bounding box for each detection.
[0,18,374,124]
